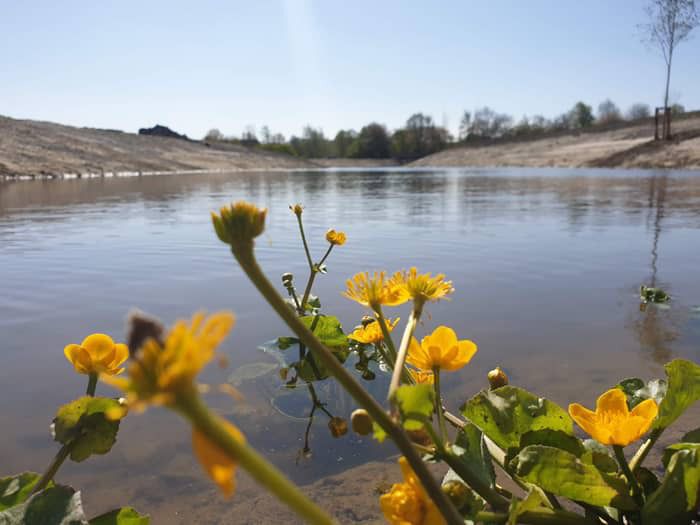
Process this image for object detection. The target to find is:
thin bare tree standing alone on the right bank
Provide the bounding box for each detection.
[640,0,700,108]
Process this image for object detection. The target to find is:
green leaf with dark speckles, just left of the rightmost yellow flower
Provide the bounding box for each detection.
[462,385,573,451]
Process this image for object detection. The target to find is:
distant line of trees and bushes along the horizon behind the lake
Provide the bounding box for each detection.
[204,99,685,160]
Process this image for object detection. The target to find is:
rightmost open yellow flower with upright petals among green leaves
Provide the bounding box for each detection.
[569,388,659,447]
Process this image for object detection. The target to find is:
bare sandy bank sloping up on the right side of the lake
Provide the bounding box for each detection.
[410,113,700,170]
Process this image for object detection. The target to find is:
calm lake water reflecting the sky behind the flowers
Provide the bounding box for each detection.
[0,169,700,523]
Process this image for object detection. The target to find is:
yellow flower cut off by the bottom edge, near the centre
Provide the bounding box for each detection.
[379,457,445,525]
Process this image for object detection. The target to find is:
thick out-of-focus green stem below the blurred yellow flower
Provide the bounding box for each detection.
[176,390,334,525]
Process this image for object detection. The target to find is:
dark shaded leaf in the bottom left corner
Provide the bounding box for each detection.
[0,485,88,525]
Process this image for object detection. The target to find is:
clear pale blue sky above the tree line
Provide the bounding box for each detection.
[0,0,700,138]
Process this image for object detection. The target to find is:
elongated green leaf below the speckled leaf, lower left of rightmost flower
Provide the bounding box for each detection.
[510,445,635,510]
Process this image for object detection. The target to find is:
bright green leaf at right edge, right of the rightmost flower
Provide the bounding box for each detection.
[653,359,700,429]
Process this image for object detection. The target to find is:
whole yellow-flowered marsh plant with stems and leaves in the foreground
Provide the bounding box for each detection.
[0,202,700,525]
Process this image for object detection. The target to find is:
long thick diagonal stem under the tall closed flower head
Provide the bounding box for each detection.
[231,241,464,525]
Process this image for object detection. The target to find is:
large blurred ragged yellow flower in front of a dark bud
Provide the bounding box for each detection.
[107,312,234,407]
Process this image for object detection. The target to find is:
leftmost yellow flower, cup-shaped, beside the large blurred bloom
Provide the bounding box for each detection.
[63,334,129,376]
